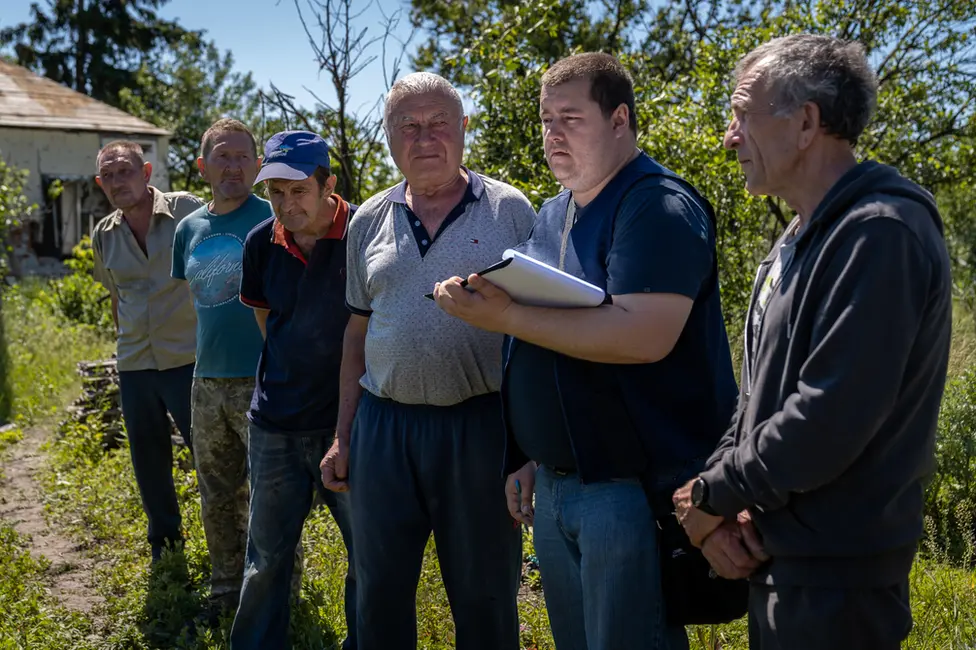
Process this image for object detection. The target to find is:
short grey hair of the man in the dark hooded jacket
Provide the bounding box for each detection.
[734,34,878,144]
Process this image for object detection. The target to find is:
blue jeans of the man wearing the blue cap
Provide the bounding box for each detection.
[230,423,356,650]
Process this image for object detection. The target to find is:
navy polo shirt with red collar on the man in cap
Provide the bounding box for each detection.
[241,195,356,436]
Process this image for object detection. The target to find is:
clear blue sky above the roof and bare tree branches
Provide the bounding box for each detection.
[0,0,422,117]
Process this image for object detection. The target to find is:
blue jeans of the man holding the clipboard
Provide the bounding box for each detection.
[534,466,688,650]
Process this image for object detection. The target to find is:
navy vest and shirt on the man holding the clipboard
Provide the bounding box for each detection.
[502,155,737,482]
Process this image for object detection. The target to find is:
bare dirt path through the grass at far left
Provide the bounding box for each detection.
[0,427,102,614]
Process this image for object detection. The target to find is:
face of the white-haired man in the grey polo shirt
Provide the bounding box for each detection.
[387,93,468,187]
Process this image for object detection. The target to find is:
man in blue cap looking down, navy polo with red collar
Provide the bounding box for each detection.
[231,131,356,650]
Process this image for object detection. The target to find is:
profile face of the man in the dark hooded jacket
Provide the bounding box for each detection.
[724,72,801,196]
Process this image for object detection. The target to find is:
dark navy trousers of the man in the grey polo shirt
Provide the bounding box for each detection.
[349,391,521,650]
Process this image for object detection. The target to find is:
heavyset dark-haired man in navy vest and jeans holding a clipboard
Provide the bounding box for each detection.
[435,54,736,650]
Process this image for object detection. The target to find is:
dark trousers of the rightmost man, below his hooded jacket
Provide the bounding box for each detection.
[749,579,912,650]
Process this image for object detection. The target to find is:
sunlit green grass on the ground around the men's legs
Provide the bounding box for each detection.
[0,286,976,650]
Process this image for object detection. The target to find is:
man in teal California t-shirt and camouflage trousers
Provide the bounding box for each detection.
[173,119,272,623]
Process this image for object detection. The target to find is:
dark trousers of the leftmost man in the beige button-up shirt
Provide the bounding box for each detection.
[119,363,194,558]
